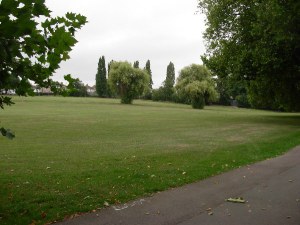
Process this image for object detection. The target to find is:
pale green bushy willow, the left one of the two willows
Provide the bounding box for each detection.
[108,62,149,104]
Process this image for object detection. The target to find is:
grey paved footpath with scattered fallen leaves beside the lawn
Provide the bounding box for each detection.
[56,147,300,225]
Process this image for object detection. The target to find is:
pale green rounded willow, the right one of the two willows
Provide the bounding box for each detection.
[176,64,218,109]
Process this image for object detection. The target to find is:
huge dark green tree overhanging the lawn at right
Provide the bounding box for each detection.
[199,0,300,111]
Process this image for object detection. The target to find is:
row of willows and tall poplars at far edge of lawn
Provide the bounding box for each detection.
[96,56,219,109]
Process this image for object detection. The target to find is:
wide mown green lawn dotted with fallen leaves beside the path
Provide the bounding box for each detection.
[0,97,300,224]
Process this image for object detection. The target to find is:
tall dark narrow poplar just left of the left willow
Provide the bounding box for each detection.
[96,56,107,97]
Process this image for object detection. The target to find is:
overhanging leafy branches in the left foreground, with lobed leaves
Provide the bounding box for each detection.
[0,0,87,136]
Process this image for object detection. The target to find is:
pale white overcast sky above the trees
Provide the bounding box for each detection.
[46,0,205,87]
